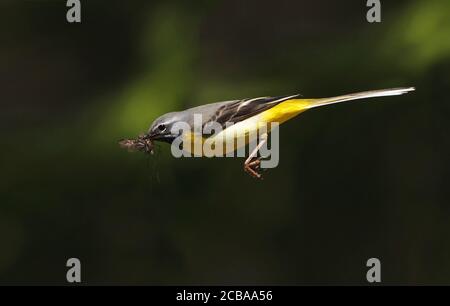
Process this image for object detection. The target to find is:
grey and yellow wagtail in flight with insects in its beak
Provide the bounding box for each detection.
[119,87,415,178]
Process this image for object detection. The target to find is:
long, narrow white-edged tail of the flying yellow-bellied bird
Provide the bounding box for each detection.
[306,87,415,108]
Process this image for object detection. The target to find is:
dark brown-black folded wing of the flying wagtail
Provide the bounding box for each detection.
[204,95,300,127]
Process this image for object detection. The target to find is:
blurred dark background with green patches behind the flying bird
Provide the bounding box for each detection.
[0,0,450,285]
